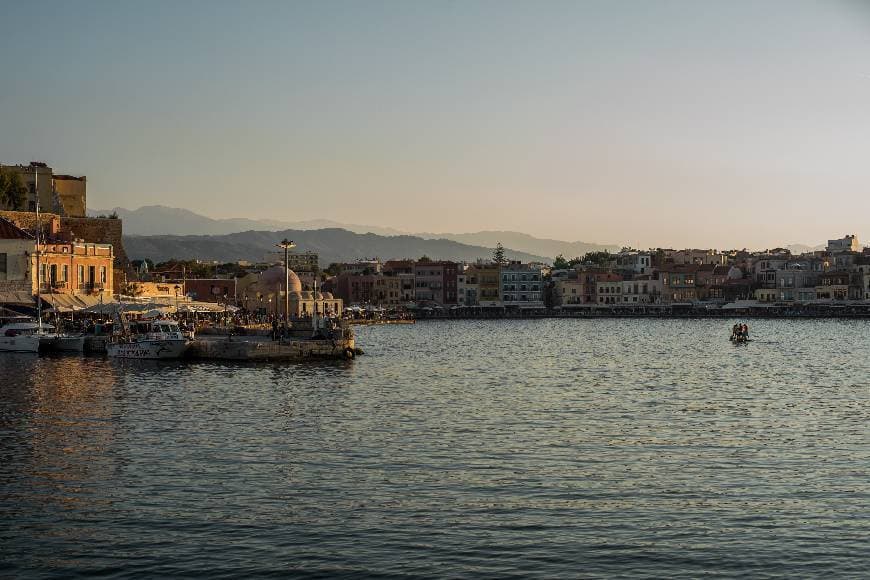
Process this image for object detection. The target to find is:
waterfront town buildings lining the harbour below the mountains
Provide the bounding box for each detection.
[0,162,870,317]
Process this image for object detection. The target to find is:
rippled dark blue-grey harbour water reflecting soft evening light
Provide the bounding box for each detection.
[0,320,870,578]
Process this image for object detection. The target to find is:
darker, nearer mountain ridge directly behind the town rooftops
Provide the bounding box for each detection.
[124,228,551,267]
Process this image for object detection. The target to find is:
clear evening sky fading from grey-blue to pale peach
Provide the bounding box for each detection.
[0,0,870,248]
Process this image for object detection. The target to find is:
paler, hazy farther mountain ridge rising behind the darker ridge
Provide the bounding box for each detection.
[88,205,620,260]
